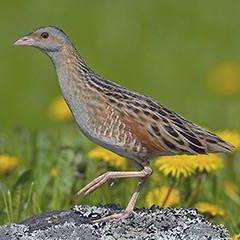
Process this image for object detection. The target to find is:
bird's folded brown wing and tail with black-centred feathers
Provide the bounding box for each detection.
[100,84,233,155]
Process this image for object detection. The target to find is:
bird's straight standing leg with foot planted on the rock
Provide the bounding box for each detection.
[93,176,147,223]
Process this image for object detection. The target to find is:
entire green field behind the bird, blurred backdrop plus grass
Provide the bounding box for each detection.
[0,0,240,233]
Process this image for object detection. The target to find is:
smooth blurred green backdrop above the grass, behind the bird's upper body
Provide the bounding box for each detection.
[0,0,240,130]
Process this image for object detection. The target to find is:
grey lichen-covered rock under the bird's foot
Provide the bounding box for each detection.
[0,205,229,240]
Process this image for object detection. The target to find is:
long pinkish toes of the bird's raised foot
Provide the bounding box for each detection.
[77,172,109,196]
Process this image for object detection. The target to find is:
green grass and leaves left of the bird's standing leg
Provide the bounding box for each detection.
[0,125,142,223]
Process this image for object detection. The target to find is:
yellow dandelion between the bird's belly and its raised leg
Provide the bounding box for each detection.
[88,147,127,169]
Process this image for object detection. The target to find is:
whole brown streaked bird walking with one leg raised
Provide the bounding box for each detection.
[14,26,234,222]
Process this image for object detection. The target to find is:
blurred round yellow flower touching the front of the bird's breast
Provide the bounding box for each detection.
[48,97,72,121]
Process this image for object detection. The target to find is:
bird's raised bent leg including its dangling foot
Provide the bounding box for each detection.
[77,166,152,196]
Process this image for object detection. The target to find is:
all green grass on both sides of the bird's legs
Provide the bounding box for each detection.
[0,123,240,236]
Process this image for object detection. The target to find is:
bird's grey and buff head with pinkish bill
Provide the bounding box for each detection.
[14,26,70,53]
